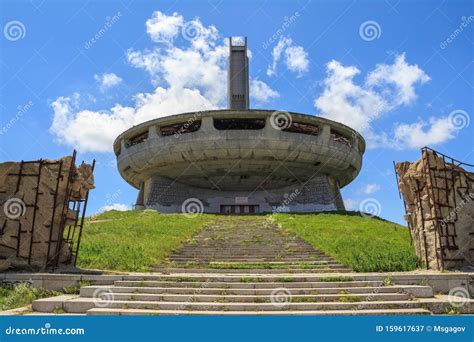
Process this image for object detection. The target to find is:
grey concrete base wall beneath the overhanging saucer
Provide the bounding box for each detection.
[144,176,344,213]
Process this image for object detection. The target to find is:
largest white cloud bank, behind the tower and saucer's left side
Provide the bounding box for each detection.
[50,11,278,152]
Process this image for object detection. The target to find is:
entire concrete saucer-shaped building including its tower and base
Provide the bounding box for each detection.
[114,39,365,213]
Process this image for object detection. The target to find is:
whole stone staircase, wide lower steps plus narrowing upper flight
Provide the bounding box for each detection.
[33,216,470,315]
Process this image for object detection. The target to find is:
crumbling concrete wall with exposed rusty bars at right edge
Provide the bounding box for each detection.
[396,150,474,270]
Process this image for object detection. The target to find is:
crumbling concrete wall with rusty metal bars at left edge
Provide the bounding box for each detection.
[0,157,94,269]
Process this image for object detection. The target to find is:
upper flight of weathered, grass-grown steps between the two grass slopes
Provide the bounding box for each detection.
[158,216,350,273]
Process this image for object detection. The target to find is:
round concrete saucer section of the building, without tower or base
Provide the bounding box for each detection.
[114,110,365,190]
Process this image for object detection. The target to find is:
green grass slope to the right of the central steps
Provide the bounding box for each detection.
[274,212,417,272]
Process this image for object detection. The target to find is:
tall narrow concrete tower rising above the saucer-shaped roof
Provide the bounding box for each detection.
[227,37,249,110]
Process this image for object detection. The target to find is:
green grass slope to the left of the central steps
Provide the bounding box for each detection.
[77,210,213,272]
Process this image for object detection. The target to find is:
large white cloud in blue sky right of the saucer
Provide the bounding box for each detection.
[314,54,457,149]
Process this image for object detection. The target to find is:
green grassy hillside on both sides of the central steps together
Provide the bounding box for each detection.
[77,211,417,272]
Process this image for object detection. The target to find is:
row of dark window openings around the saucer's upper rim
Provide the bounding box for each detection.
[119,119,352,153]
